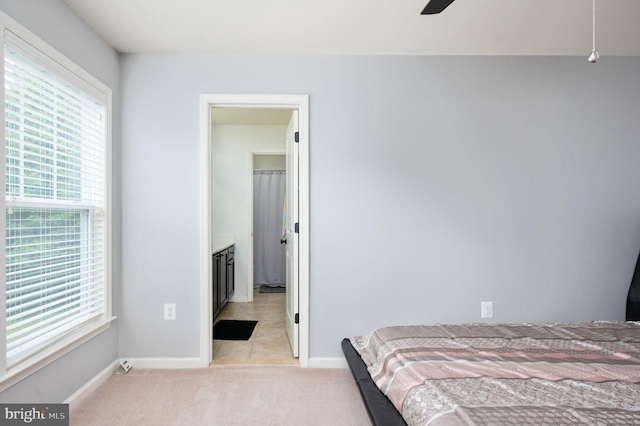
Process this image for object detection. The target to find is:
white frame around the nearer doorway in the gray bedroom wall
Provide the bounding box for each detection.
[198,94,309,368]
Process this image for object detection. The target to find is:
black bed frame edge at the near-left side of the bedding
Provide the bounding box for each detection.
[342,339,407,426]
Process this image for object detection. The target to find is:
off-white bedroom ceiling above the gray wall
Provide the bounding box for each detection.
[65,0,640,57]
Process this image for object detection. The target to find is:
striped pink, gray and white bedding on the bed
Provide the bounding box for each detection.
[350,321,640,426]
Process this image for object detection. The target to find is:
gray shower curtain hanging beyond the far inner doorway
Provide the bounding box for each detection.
[253,170,286,287]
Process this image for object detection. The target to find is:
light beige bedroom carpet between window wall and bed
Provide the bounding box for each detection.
[70,366,371,426]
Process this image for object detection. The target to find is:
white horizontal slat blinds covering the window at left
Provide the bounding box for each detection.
[4,33,107,367]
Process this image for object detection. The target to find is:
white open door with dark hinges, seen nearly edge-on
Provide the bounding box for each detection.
[285,110,299,357]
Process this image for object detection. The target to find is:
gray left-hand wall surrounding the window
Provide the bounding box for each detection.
[0,0,121,402]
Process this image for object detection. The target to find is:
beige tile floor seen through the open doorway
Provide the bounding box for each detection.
[212,289,299,365]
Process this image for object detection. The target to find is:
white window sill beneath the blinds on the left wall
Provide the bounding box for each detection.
[0,317,117,392]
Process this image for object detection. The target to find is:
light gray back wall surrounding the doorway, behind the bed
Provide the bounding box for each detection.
[120,54,640,357]
